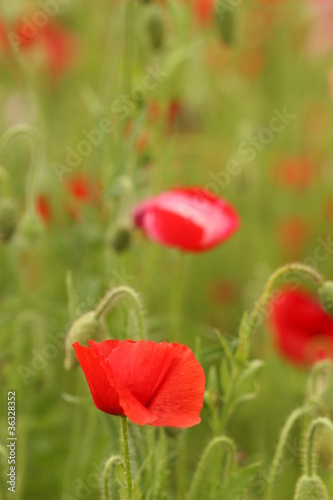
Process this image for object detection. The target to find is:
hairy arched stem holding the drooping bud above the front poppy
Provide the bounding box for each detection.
[95,285,145,340]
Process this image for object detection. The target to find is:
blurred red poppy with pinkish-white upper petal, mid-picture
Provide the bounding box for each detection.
[134,187,240,252]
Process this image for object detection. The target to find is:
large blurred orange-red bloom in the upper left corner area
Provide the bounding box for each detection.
[15,21,74,75]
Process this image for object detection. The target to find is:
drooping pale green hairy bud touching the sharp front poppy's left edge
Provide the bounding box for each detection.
[64,311,104,370]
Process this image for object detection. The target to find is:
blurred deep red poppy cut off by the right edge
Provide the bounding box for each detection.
[271,289,333,365]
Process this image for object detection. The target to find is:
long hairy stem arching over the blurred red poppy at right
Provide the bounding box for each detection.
[237,262,324,360]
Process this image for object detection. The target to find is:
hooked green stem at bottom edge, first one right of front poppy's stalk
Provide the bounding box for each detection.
[186,436,236,500]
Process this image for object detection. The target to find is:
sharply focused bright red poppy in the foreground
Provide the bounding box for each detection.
[73,340,205,427]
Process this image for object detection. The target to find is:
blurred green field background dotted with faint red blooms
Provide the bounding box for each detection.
[0,0,333,500]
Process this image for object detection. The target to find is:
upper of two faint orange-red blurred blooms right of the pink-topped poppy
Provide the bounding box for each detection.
[275,156,316,189]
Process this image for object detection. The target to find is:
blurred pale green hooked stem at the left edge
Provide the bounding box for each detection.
[0,124,44,210]
